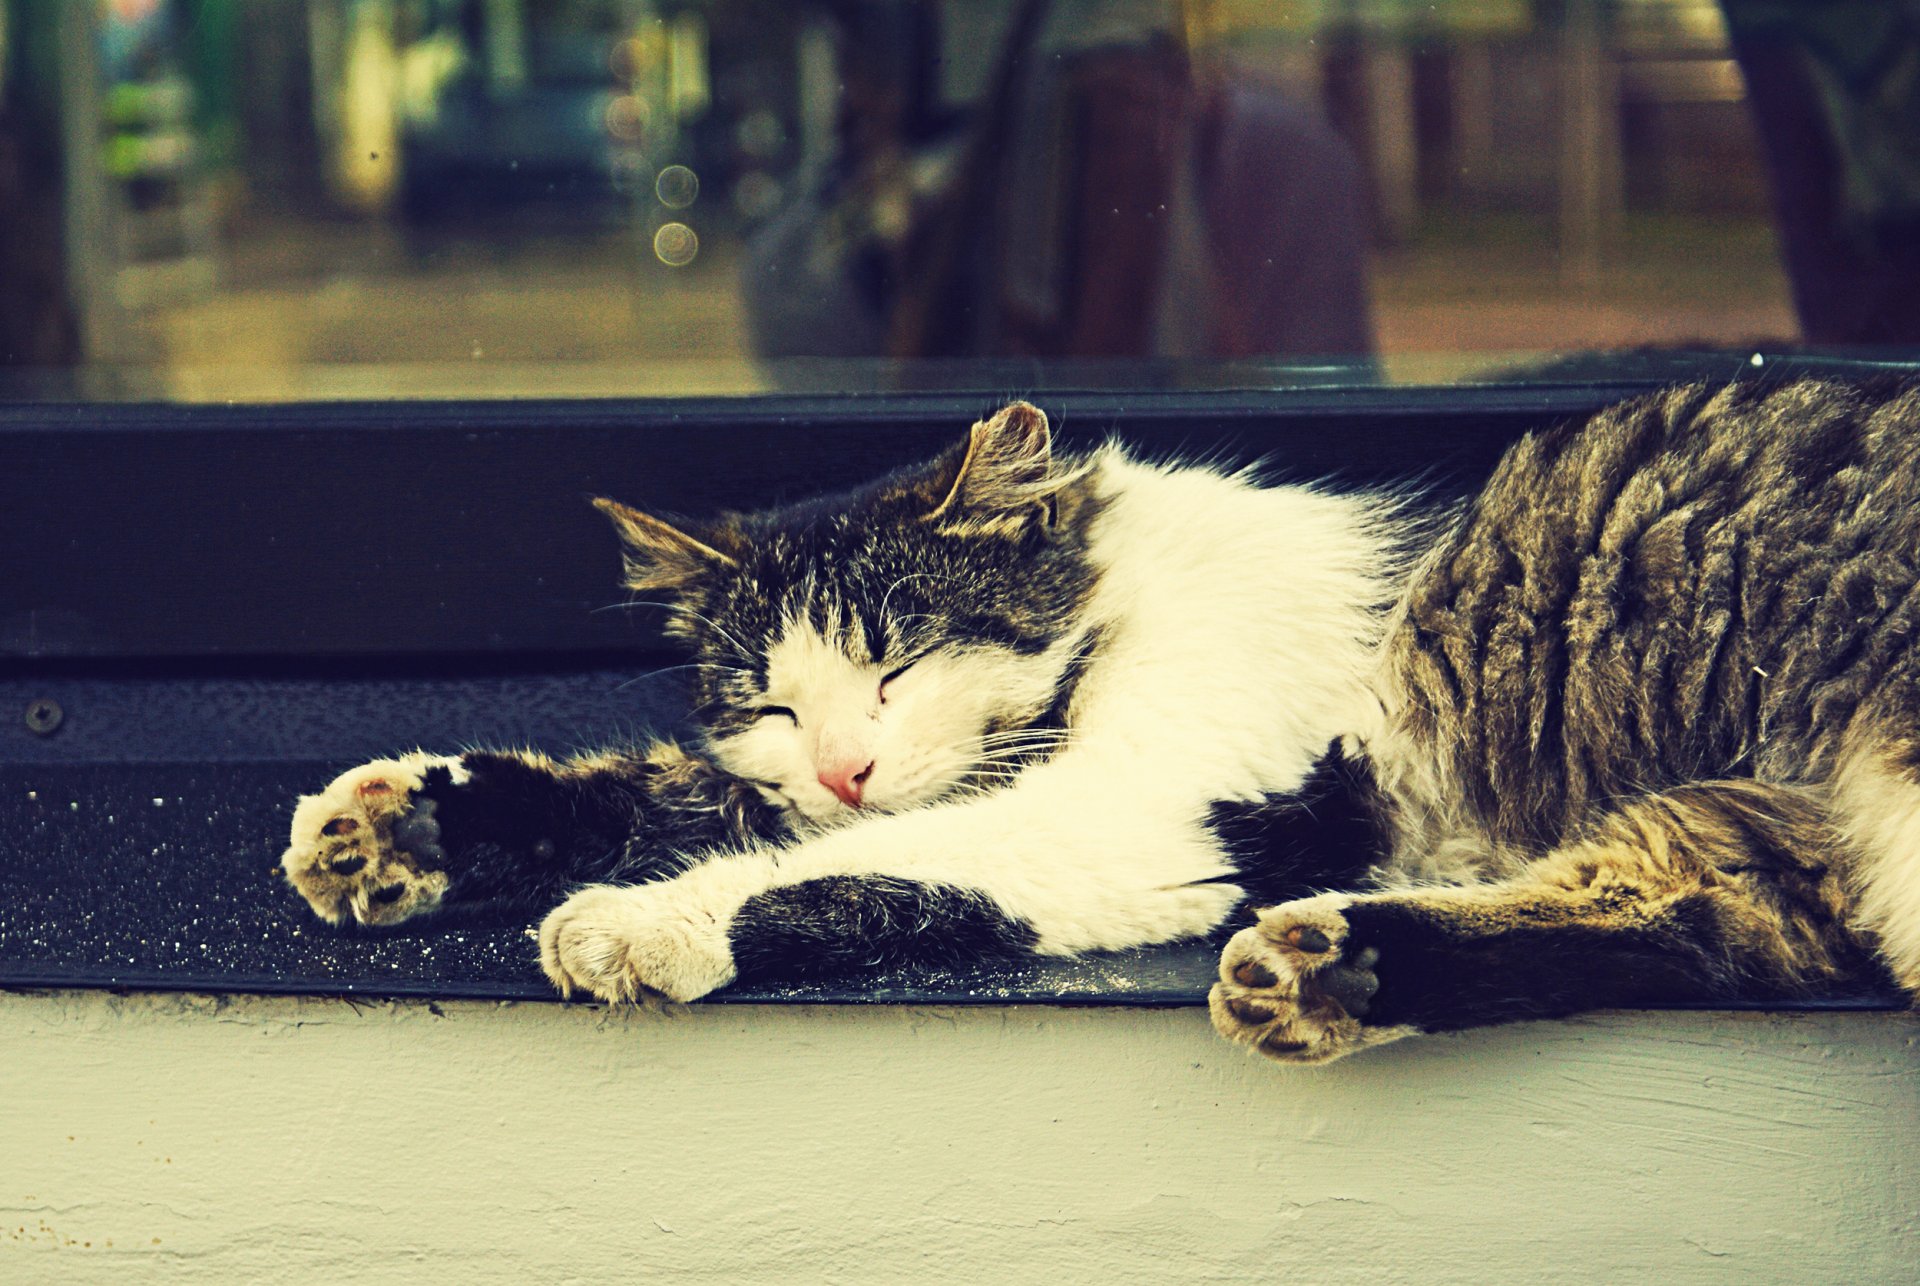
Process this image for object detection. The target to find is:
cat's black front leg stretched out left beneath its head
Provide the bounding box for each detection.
[280,743,785,925]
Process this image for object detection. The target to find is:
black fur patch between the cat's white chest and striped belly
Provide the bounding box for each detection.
[1208,743,1390,908]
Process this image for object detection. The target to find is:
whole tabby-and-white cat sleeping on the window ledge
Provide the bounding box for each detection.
[282,382,1920,1061]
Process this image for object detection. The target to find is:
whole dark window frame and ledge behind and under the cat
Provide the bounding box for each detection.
[0,372,1903,1008]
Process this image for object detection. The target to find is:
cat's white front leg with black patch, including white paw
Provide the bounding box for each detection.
[540,762,1290,1000]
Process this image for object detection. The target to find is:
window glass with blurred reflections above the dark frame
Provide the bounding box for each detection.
[0,0,1920,401]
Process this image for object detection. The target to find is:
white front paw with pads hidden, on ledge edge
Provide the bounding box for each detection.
[540,881,735,1004]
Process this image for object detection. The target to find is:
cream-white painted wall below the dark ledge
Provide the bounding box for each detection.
[0,992,1920,1286]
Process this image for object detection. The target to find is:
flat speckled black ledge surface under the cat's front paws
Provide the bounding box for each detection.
[0,756,1213,1006]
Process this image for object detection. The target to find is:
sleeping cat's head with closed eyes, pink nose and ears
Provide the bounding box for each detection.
[595,403,1098,822]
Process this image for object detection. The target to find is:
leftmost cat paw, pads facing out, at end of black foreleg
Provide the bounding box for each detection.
[280,754,465,925]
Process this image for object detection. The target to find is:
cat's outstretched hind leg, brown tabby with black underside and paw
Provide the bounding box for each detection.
[1210,781,1878,1063]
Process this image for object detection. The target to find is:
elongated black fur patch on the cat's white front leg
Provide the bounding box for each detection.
[728,875,1039,983]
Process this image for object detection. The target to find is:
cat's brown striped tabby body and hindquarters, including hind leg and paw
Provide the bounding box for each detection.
[1212,382,1920,1061]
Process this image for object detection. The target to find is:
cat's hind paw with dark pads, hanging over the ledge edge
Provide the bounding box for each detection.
[1208,893,1413,1063]
